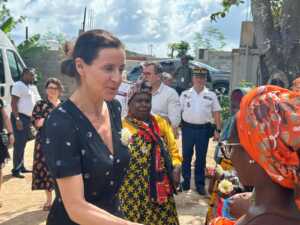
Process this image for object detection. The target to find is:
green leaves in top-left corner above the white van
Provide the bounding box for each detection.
[0,1,25,33]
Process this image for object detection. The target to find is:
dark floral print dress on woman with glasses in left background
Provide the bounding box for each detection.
[32,99,55,191]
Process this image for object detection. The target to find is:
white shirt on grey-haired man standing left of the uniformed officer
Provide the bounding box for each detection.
[152,83,181,127]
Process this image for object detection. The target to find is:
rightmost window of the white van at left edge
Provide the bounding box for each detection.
[6,50,24,81]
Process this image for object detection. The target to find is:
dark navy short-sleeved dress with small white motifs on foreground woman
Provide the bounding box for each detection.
[42,100,130,225]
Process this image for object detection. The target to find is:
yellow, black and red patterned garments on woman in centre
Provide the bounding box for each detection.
[119,116,182,225]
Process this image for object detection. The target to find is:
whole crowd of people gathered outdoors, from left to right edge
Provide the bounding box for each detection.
[0,30,300,225]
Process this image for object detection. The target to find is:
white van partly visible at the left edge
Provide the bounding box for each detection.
[0,30,25,113]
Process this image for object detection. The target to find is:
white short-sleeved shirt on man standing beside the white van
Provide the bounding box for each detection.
[11,81,41,117]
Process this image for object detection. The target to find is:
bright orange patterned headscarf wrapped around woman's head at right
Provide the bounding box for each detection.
[237,85,300,207]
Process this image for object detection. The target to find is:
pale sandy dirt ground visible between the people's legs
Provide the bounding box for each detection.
[0,142,214,225]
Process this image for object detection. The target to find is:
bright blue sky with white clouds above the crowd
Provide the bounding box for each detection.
[7,0,248,57]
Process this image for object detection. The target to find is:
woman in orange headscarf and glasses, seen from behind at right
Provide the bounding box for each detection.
[211,85,300,225]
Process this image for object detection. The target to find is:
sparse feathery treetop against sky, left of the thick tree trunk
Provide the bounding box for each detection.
[193,26,226,50]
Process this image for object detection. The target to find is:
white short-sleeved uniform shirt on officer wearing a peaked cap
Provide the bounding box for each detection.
[180,87,221,125]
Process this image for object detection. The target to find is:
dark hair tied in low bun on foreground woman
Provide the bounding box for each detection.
[61,29,124,81]
